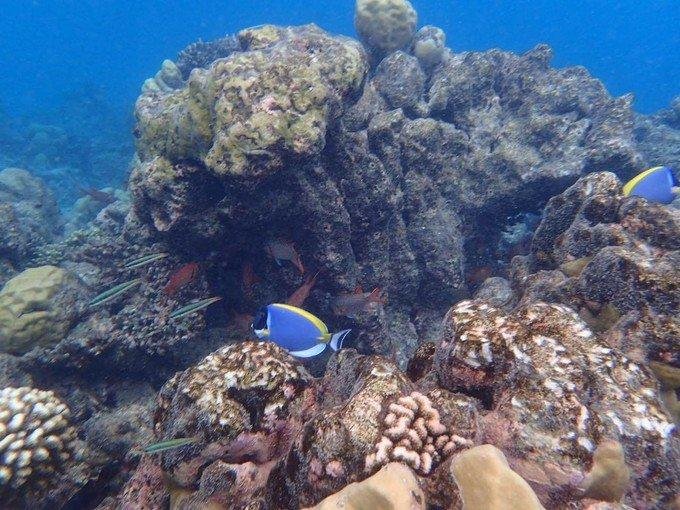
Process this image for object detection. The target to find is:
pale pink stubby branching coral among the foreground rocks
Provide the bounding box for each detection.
[366,391,472,475]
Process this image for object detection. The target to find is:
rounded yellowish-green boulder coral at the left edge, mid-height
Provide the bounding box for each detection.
[0,266,79,354]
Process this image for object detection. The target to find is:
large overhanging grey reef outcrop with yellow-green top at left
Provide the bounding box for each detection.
[130,11,641,366]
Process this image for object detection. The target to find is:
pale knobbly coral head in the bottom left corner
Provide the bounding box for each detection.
[0,387,76,501]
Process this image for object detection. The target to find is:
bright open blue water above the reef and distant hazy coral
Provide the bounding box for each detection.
[0,0,680,115]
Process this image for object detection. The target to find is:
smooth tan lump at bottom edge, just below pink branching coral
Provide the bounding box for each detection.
[307,462,427,510]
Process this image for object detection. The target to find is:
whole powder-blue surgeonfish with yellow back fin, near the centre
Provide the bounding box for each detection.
[252,303,351,358]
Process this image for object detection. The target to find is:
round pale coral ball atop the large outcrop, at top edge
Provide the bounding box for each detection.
[354,0,418,54]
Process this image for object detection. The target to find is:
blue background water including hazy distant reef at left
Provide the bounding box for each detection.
[0,0,680,209]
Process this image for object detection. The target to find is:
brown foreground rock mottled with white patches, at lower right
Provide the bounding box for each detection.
[435,302,680,506]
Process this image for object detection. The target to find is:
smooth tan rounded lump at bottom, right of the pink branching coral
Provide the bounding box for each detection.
[451,444,544,510]
